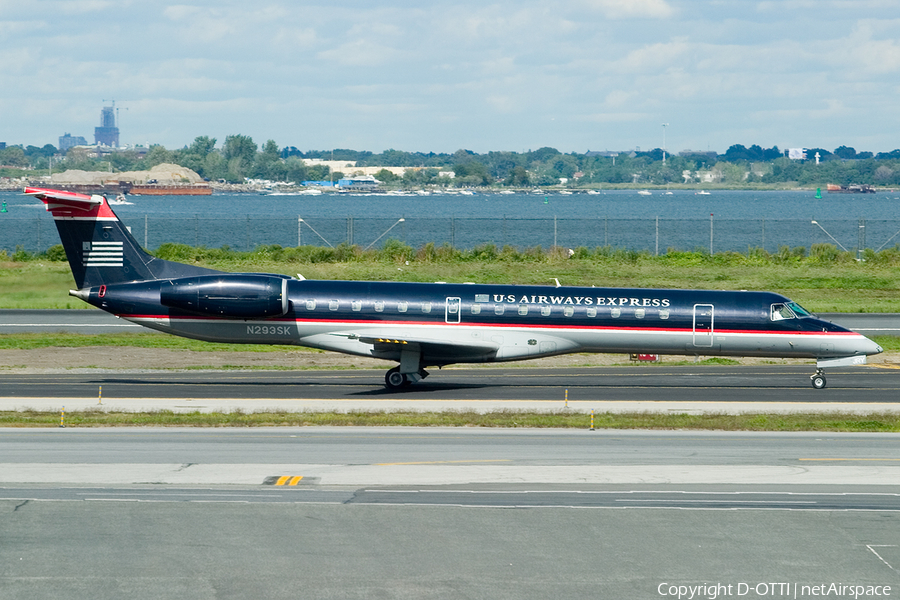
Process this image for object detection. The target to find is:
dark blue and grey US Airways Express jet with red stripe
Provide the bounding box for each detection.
[24,187,882,390]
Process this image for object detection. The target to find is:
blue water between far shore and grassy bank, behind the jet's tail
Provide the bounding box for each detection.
[0,190,900,253]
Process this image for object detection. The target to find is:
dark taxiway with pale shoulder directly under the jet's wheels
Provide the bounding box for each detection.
[0,365,900,413]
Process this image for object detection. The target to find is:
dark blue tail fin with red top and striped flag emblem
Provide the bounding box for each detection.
[25,187,219,289]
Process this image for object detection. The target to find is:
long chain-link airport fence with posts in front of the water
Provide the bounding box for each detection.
[0,213,900,254]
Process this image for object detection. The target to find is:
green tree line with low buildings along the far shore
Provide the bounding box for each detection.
[0,135,900,187]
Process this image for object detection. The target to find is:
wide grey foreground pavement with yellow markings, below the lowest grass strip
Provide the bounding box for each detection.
[0,428,900,600]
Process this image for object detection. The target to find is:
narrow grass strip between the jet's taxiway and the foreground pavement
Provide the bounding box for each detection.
[0,410,900,432]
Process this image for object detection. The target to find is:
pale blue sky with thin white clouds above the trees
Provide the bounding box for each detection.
[0,0,900,153]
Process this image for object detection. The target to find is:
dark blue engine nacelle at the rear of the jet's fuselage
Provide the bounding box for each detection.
[159,275,291,319]
